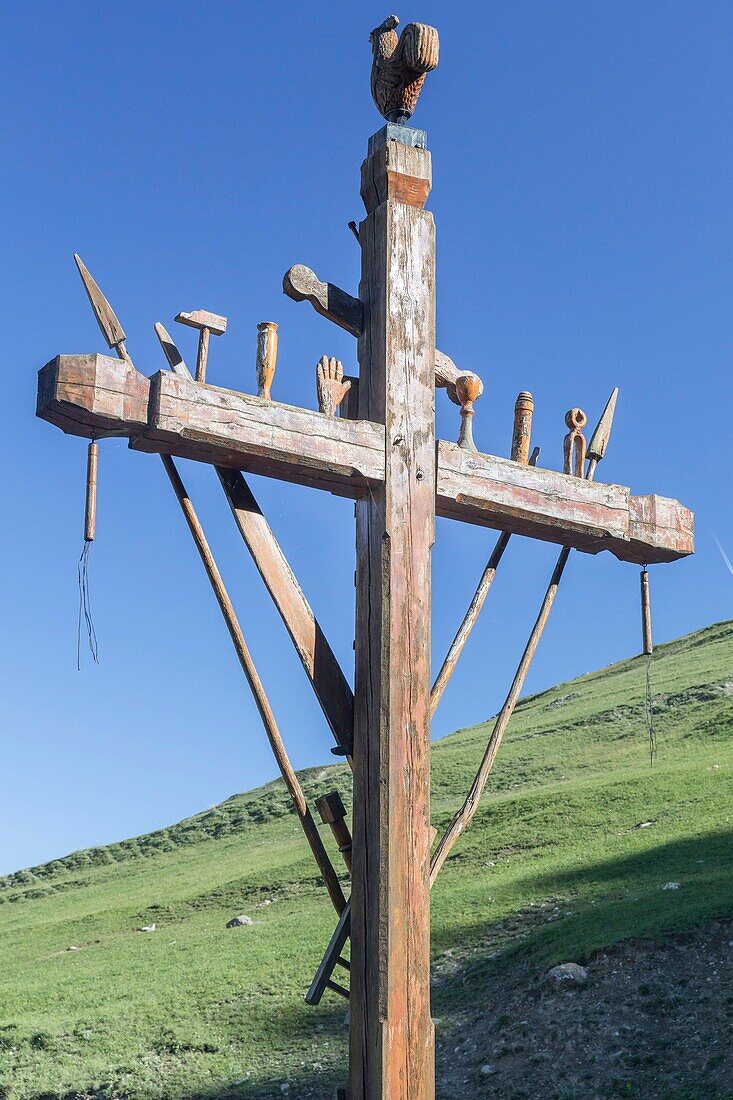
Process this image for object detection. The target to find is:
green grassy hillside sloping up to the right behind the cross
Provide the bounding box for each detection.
[0,623,733,1100]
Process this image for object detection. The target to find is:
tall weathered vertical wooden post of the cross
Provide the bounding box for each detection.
[350,127,435,1100]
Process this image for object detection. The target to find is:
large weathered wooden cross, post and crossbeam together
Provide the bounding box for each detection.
[37,73,693,1100]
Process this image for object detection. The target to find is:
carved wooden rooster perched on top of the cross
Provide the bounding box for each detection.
[369,15,440,122]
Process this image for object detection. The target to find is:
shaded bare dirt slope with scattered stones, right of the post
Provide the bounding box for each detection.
[438,922,733,1100]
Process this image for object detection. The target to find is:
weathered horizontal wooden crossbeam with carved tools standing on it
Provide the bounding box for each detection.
[36,354,693,564]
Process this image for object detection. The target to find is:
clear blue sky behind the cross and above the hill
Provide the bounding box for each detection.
[0,0,733,872]
